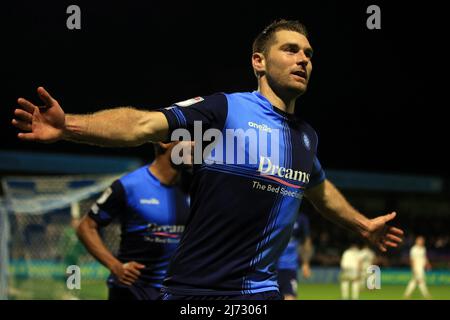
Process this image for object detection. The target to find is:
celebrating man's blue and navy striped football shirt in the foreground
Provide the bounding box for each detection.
[160,92,325,295]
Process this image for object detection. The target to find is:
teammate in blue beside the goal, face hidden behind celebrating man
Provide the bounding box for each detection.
[77,143,189,300]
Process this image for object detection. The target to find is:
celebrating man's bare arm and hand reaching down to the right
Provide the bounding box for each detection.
[305,180,403,252]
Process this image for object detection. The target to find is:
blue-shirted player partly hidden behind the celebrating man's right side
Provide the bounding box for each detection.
[277,212,313,300]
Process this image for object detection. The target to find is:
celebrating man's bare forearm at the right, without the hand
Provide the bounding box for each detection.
[307,180,369,236]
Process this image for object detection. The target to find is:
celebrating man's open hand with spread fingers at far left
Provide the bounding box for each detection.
[12,87,65,143]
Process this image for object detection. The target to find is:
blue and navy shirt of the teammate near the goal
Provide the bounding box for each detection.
[88,166,189,288]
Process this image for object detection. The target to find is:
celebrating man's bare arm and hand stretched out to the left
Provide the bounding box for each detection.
[12,87,169,147]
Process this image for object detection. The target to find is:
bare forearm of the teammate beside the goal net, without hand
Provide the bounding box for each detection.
[77,224,121,270]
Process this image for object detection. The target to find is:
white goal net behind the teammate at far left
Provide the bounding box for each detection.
[0,175,124,299]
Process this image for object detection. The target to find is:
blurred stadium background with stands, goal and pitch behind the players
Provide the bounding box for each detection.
[0,152,450,300]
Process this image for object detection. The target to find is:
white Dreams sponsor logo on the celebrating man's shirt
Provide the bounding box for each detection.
[258,157,309,189]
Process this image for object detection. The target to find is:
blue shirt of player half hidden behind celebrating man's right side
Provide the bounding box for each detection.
[278,212,310,271]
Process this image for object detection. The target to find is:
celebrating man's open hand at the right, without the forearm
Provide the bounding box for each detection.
[365,212,403,252]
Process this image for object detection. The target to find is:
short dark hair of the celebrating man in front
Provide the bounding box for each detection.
[253,19,308,53]
